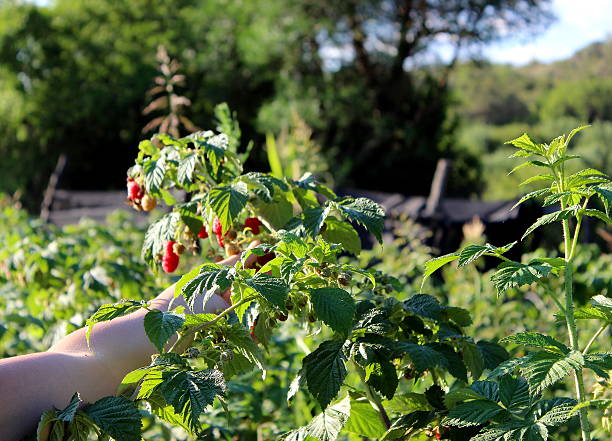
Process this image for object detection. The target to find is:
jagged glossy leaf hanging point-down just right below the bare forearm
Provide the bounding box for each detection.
[156,370,226,432]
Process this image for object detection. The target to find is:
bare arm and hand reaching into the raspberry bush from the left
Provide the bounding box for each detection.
[0,242,257,441]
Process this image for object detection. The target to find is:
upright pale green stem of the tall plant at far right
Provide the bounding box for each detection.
[563,262,591,441]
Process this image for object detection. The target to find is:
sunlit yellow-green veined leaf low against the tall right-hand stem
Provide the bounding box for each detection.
[520,351,584,395]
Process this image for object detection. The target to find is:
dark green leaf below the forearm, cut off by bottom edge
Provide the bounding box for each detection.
[84,397,141,441]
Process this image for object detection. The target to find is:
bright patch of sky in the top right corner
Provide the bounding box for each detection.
[482,0,612,64]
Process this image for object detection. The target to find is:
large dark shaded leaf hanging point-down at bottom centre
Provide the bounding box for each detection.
[302,340,347,408]
